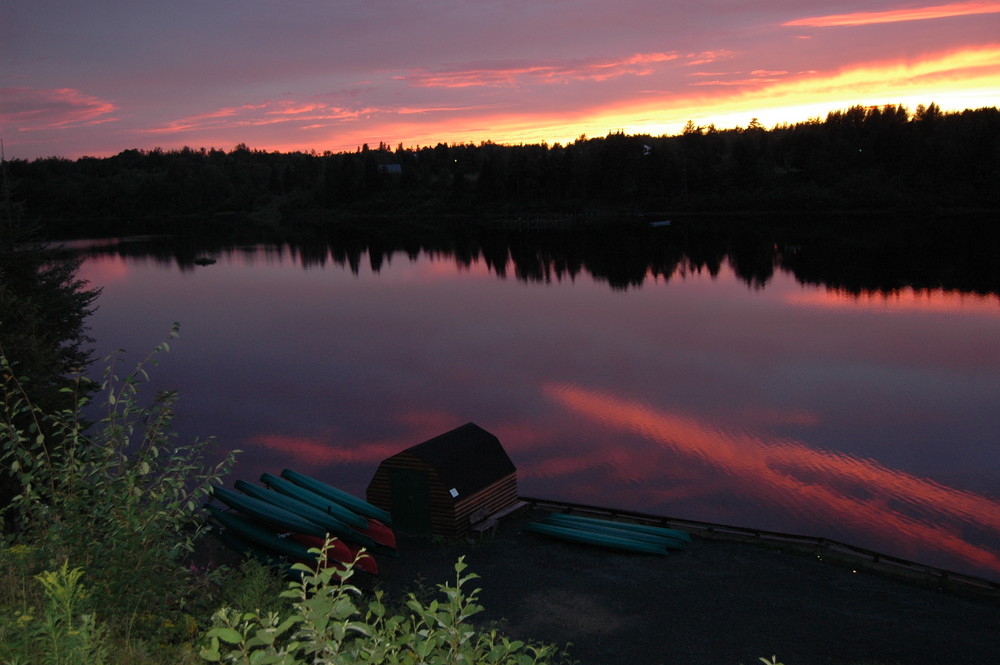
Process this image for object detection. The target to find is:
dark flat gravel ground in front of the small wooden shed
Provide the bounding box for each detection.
[374,506,1000,665]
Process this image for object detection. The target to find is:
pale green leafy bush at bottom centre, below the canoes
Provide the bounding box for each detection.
[201,543,565,665]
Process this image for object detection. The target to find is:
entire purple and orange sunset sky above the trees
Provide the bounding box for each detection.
[0,0,1000,159]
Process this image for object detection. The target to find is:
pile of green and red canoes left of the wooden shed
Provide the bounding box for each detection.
[207,469,397,575]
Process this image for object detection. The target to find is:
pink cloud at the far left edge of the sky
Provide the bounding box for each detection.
[0,88,118,131]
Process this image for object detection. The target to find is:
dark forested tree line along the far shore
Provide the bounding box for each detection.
[9,104,1000,231]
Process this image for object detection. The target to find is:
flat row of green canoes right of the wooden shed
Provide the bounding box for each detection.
[524,513,691,555]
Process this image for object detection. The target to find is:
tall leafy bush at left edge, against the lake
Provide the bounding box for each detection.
[0,326,235,636]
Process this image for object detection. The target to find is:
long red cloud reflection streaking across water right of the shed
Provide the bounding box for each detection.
[546,385,1000,572]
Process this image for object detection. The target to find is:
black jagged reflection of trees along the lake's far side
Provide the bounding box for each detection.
[74,218,1000,295]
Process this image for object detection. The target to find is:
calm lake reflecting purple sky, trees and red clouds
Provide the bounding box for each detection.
[72,219,1000,580]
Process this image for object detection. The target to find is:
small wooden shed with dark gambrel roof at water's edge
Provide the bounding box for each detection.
[367,423,518,538]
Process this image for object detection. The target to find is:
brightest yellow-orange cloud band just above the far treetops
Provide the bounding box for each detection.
[306,46,1000,150]
